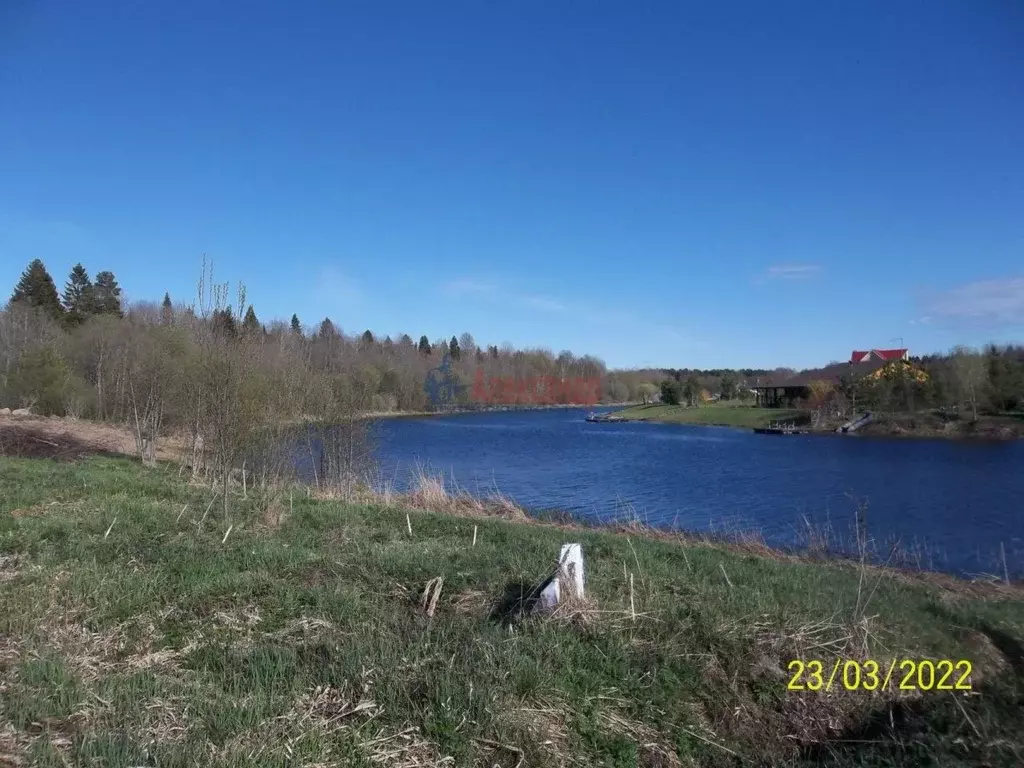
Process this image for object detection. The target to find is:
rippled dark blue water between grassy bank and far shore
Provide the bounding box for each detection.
[364,410,1024,575]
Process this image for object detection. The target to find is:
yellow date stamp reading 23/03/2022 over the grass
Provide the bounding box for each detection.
[786,658,973,691]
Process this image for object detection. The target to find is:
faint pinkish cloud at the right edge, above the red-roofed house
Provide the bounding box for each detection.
[921,278,1024,329]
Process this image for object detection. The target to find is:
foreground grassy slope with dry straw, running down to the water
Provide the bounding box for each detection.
[0,458,1024,768]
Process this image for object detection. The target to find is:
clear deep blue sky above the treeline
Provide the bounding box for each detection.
[0,0,1024,368]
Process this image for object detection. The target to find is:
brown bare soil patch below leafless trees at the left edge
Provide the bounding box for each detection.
[0,416,184,461]
